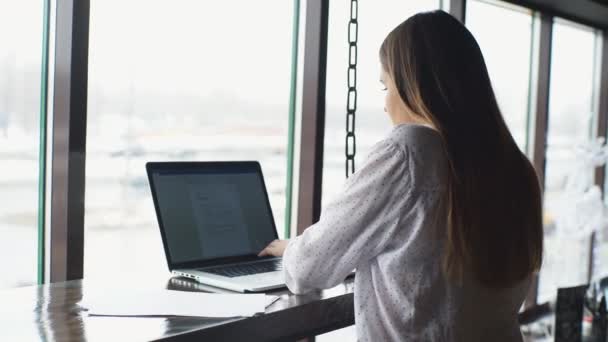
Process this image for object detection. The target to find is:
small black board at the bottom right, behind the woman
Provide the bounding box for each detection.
[555,285,588,342]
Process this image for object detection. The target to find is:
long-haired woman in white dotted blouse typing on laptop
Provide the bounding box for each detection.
[260,11,543,341]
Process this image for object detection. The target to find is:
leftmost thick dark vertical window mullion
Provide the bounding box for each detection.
[49,0,90,282]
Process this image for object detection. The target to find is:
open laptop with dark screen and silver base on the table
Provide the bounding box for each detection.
[146,161,285,292]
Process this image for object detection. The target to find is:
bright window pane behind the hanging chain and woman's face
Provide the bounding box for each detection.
[322,0,439,205]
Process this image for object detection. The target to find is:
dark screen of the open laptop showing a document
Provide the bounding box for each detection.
[149,163,276,264]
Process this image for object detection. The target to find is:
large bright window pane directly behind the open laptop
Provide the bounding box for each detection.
[85,0,293,278]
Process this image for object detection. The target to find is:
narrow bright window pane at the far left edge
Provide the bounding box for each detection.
[0,0,43,288]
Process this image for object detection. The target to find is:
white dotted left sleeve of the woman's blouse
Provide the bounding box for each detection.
[283,140,409,293]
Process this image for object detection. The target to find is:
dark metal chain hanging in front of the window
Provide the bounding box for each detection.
[346,0,359,178]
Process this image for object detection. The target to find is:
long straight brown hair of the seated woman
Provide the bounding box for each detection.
[380,11,543,288]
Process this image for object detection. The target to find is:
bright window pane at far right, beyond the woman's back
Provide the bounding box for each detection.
[539,21,595,301]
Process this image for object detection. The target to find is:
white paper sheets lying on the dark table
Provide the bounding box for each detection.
[80,290,278,317]
